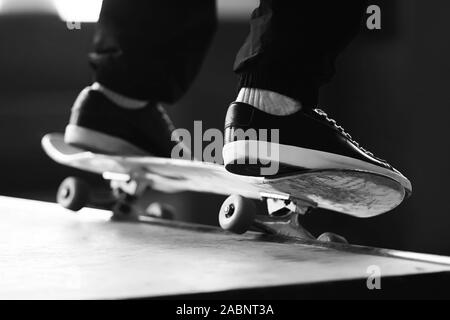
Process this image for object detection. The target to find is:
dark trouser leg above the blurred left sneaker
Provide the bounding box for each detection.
[90,0,217,103]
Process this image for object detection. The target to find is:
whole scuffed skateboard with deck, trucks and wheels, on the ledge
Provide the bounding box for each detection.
[42,133,408,241]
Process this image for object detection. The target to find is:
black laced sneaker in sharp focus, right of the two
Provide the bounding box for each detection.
[223,102,411,190]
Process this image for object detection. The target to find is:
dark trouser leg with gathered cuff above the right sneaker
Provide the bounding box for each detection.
[234,0,365,107]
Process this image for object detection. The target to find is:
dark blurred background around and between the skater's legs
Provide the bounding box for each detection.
[0,0,450,255]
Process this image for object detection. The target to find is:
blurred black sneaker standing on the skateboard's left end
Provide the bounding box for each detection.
[64,87,175,157]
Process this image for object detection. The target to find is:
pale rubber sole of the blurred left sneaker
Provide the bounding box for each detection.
[64,125,151,156]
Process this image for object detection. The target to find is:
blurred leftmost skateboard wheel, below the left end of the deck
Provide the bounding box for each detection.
[56,177,89,211]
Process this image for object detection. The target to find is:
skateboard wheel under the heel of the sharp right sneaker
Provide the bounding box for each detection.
[219,195,257,234]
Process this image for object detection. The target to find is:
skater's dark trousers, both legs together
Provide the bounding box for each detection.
[90,0,365,106]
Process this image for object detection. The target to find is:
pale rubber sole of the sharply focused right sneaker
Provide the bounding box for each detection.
[222,140,412,192]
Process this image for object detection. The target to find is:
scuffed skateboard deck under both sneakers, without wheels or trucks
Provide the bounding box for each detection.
[42,133,406,218]
